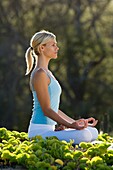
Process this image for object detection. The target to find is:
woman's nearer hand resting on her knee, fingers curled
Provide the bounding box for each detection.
[70,119,88,130]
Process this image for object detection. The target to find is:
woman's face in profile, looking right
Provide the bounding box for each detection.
[42,39,59,59]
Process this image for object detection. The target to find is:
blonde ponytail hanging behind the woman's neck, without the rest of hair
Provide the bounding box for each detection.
[25,47,34,75]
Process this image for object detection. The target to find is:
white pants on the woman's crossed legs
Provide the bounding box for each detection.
[28,123,98,144]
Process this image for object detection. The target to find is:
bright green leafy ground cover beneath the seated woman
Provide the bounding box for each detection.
[0,128,113,170]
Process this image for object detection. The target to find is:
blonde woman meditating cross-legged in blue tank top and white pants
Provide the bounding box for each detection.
[25,30,98,144]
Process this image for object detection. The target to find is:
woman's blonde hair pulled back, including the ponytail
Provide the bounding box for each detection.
[25,30,56,75]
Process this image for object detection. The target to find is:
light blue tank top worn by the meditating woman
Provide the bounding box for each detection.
[31,70,61,125]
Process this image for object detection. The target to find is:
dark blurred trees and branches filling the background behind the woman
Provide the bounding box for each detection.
[0,0,113,132]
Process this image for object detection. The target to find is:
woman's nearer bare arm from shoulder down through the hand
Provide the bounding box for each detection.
[32,69,88,129]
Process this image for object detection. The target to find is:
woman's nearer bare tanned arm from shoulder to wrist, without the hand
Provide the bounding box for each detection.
[33,69,70,127]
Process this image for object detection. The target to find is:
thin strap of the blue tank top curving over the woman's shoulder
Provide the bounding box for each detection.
[30,67,51,91]
